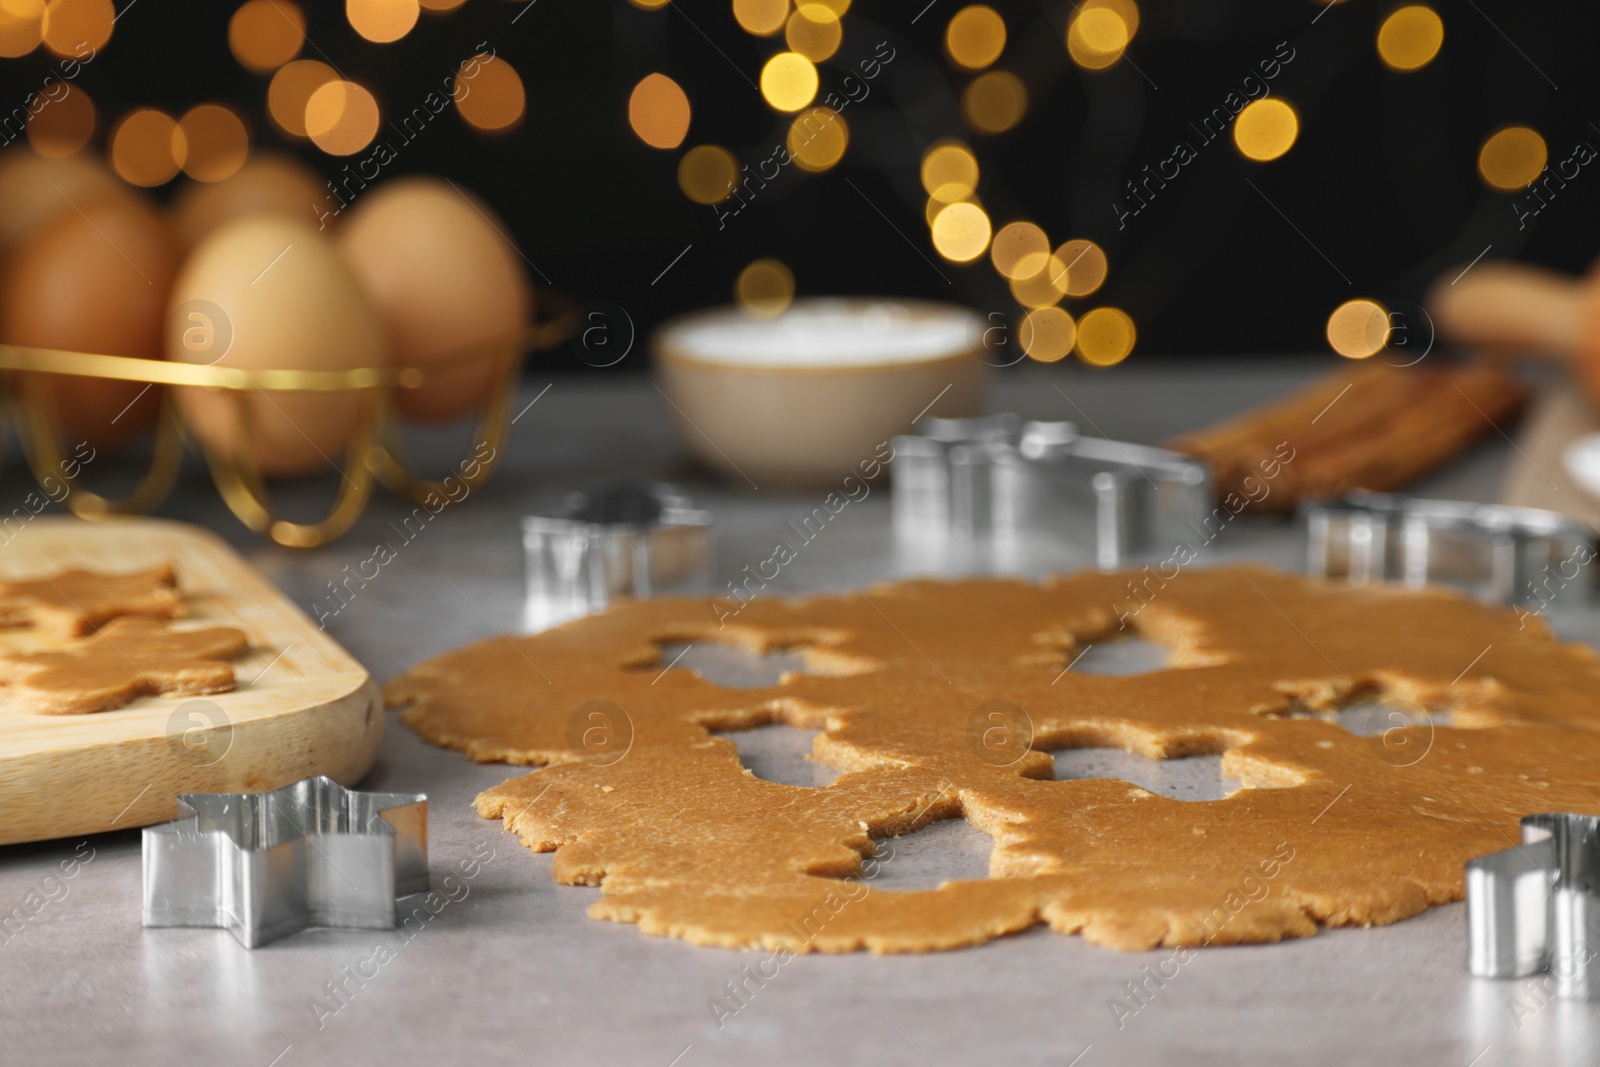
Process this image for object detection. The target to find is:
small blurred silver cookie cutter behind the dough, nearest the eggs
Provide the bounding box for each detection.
[522,480,712,630]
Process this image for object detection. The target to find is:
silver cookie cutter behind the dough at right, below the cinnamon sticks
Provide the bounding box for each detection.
[1302,491,1595,603]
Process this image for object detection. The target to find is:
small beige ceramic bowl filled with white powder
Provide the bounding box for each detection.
[651,298,987,486]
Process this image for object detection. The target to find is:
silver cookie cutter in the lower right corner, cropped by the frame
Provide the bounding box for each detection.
[1467,814,1600,1000]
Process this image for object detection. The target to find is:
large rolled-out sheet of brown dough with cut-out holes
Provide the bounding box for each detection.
[387,568,1600,952]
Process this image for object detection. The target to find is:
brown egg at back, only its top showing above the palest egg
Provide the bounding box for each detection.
[173,152,339,250]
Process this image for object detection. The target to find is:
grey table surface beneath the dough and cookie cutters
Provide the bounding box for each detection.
[0,357,1600,1067]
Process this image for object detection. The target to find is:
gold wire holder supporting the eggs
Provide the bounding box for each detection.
[0,298,574,549]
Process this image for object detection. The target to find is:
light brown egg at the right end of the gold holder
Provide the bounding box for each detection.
[336,178,533,422]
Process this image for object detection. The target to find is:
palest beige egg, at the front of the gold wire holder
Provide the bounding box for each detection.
[166,216,389,475]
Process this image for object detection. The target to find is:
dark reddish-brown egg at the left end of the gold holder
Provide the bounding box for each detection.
[0,192,178,446]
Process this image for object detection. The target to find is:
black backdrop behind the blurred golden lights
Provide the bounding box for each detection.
[0,0,1600,368]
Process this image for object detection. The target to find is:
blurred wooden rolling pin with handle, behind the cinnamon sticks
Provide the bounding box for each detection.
[1426,259,1600,408]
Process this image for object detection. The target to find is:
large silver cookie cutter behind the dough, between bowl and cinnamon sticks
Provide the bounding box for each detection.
[891,414,1214,568]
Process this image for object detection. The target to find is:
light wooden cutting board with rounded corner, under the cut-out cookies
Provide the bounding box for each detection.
[0,518,384,845]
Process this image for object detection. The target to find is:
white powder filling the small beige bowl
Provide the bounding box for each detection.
[661,298,984,366]
